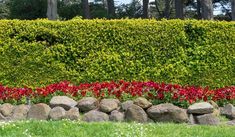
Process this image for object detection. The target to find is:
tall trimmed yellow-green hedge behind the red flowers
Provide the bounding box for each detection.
[0,19,235,88]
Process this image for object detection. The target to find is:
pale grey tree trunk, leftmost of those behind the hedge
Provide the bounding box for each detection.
[47,0,57,20]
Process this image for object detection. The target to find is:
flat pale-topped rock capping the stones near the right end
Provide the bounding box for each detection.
[188,102,214,114]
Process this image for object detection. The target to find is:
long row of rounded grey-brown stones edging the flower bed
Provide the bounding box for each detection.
[0,96,235,125]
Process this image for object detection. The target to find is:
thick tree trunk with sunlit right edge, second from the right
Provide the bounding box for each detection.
[201,0,213,20]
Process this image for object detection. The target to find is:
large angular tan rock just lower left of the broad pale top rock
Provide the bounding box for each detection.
[27,103,51,120]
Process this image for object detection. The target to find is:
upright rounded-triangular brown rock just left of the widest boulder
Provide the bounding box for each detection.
[125,104,148,123]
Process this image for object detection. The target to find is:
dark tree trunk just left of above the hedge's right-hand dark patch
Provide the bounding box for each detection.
[175,0,184,19]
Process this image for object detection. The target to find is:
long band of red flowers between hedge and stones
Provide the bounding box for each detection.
[0,80,235,104]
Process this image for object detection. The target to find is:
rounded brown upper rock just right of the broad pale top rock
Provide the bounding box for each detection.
[77,97,98,112]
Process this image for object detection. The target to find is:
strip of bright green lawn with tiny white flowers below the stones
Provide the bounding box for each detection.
[0,120,235,137]
